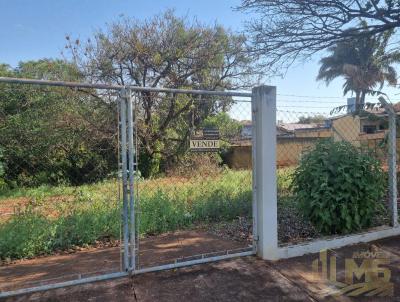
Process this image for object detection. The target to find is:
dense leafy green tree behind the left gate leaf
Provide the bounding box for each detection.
[0,59,117,187]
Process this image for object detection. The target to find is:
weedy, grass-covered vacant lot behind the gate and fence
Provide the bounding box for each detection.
[0,168,387,262]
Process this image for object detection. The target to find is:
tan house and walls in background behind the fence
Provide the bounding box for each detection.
[226,99,400,169]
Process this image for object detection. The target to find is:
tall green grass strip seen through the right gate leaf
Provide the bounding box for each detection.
[139,171,251,234]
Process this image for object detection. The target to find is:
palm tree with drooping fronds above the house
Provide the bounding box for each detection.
[317,25,400,108]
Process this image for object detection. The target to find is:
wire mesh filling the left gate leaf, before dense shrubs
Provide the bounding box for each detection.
[0,84,121,291]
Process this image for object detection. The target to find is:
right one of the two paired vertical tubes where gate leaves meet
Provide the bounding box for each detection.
[127,90,136,271]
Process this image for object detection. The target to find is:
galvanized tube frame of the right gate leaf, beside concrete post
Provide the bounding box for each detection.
[119,87,257,274]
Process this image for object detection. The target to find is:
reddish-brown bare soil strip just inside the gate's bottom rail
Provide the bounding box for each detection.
[0,231,247,291]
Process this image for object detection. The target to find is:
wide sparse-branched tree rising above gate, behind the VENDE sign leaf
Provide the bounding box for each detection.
[63,11,255,177]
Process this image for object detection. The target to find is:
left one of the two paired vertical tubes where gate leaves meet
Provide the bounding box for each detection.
[119,89,129,271]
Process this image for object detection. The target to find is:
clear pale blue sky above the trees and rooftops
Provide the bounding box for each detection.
[0,0,400,119]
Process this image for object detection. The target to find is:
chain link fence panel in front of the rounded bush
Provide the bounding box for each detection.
[277,100,390,244]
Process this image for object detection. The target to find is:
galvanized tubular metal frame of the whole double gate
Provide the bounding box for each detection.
[0,78,257,298]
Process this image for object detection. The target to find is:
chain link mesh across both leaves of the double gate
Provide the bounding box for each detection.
[0,81,254,294]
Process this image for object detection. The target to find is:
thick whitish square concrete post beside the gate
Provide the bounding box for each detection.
[252,86,278,260]
